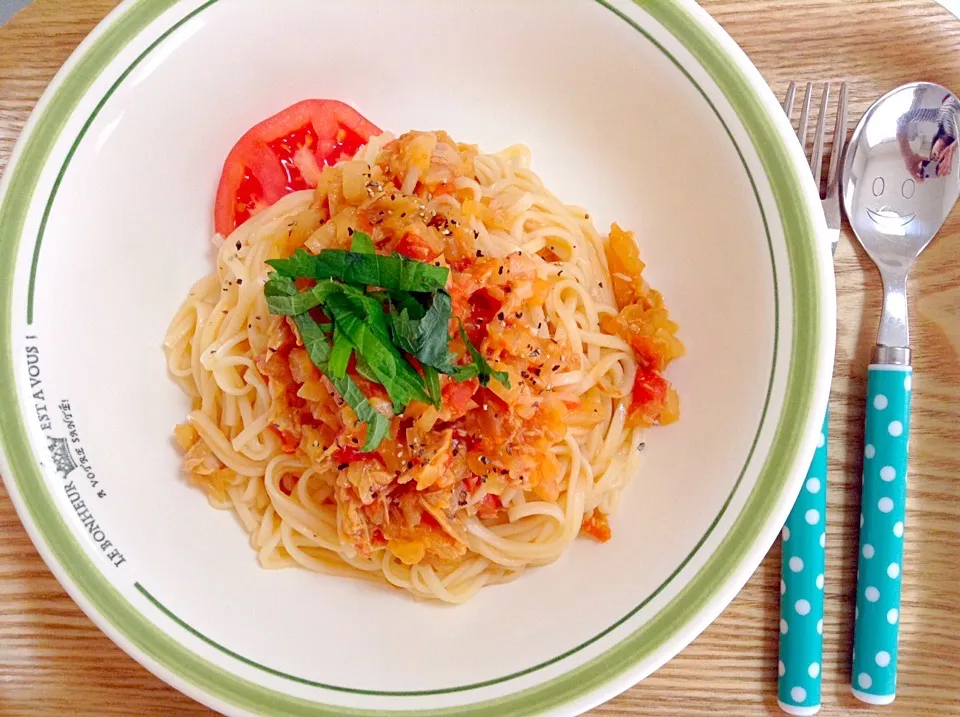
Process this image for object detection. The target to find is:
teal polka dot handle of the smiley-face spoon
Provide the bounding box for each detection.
[850,364,913,705]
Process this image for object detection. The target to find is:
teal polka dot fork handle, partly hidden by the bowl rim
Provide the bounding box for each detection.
[777,414,829,715]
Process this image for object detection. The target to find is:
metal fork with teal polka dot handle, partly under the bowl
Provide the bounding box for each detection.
[777,82,848,715]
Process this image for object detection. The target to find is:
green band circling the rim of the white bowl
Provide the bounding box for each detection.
[0,0,822,717]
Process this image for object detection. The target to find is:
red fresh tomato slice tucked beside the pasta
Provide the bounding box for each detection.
[214,100,381,236]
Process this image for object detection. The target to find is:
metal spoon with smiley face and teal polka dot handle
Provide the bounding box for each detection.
[842,82,960,704]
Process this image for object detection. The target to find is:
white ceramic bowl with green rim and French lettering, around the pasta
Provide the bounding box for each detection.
[0,0,835,716]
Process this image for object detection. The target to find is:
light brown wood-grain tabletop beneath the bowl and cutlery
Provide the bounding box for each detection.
[0,0,960,717]
